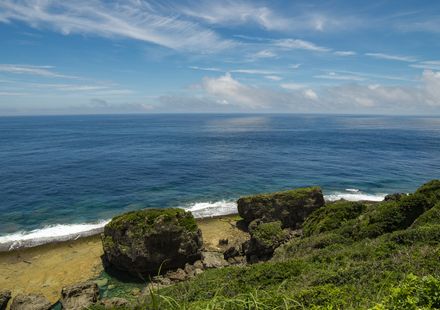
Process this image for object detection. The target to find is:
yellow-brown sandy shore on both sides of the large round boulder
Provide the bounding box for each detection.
[0,214,247,302]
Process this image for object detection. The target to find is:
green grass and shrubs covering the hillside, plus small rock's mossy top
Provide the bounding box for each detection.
[99,181,440,310]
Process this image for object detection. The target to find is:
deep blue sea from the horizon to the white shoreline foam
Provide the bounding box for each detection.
[0,114,440,248]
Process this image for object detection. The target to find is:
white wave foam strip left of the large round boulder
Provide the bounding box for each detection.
[0,220,109,251]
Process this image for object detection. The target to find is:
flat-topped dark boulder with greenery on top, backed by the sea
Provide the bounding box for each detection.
[237,187,325,229]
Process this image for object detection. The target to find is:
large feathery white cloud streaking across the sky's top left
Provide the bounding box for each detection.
[0,0,235,52]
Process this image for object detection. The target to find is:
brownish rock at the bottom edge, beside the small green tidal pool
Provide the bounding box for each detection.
[60,282,99,310]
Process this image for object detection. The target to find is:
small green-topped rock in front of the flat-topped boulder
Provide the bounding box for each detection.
[244,220,290,263]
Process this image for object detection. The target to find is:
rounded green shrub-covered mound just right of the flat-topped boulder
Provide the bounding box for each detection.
[303,201,366,236]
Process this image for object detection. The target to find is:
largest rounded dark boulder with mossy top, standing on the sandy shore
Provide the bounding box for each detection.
[102,208,203,276]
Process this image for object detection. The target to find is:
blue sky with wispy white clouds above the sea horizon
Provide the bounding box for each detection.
[0,0,440,115]
